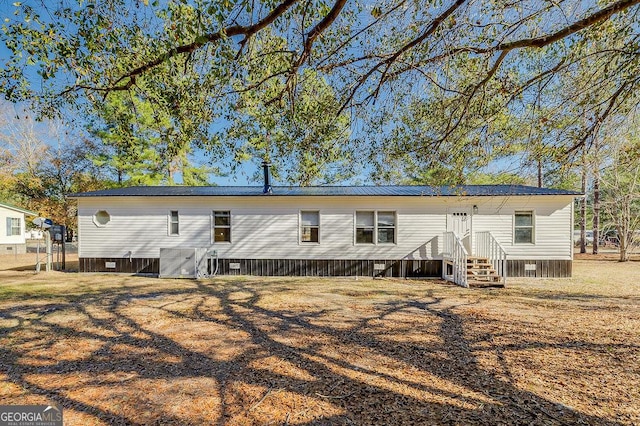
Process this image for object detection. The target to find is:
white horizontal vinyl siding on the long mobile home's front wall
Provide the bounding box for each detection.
[78,195,573,260]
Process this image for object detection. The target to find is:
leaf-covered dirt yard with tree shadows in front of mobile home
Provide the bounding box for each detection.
[0,258,640,425]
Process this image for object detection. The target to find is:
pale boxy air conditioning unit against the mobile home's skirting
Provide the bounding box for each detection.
[160,247,212,278]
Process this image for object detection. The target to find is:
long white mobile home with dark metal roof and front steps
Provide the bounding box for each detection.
[73,170,580,285]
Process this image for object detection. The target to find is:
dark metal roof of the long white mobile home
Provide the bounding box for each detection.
[70,185,582,198]
